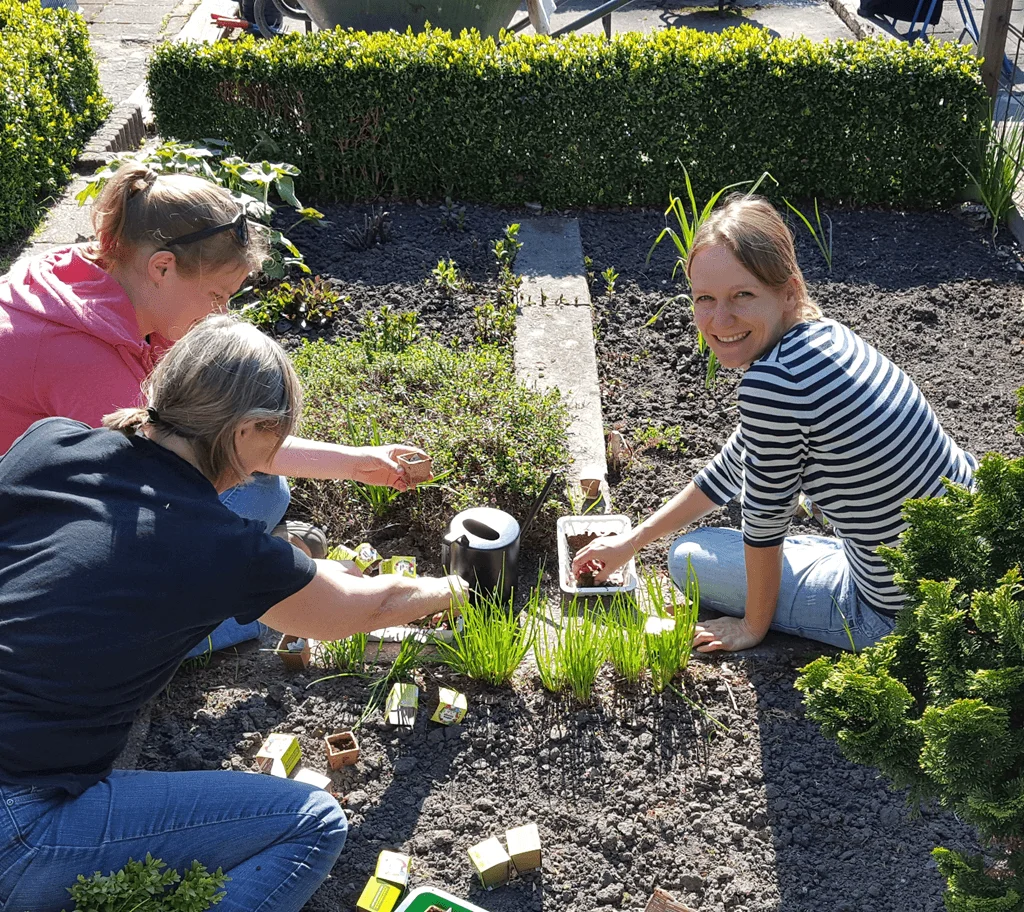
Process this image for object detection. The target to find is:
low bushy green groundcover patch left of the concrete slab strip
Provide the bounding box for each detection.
[294,314,569,542]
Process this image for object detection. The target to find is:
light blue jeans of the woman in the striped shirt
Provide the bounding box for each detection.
[669,528,896,649]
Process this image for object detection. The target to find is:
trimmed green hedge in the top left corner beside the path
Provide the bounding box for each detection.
[0,0,110,241]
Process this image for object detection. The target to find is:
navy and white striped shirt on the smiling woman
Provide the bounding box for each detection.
[693,319,978,613]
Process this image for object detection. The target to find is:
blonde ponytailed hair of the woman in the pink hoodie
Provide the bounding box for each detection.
[86,163,269,276]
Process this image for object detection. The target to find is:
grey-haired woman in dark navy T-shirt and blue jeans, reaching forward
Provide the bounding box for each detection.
[0,316,464,912]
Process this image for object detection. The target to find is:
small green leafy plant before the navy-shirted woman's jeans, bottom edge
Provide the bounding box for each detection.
[68,854,230,912]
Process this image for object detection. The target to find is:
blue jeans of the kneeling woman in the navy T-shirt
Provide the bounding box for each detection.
[0,770,348,912]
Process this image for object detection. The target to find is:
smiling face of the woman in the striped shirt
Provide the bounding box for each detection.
[689,244,800,367]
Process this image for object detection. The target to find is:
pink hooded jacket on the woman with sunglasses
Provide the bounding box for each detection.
[0,247,171,455]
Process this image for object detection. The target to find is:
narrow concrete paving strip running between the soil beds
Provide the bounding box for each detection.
[515,216,606,482]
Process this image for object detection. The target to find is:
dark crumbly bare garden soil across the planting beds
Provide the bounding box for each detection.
[139,206,1024,912]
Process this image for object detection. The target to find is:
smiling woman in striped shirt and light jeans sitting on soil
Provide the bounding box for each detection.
[574,194,977,652]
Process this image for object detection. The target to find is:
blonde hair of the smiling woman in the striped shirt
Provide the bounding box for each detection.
[686,193,821,321]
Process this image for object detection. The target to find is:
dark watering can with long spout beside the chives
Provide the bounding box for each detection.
[441,472,555,604]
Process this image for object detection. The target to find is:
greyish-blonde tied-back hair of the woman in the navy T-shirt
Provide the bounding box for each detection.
[103,315,302,484]
